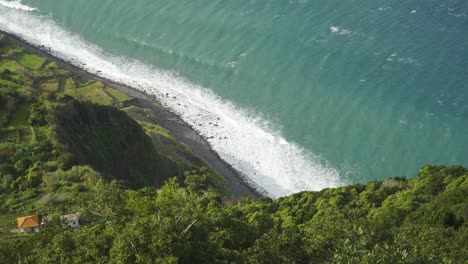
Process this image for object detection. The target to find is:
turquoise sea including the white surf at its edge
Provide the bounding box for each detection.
[0,0,468,195]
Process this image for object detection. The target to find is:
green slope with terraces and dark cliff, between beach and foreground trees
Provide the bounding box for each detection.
[0,35,224,227]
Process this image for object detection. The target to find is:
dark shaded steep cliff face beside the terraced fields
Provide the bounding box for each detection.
[53,100,179,187]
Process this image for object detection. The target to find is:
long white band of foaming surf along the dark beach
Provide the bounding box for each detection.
[0,6,345,197]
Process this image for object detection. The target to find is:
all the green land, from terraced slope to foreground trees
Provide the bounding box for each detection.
[0,35,468,263]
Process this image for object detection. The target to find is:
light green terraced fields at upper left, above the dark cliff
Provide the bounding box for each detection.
[0,35,132,146]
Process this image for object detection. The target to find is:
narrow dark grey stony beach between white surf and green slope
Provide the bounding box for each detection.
[0,30,267,199]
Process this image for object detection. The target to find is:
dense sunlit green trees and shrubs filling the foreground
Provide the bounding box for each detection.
[0,166,468,263]
